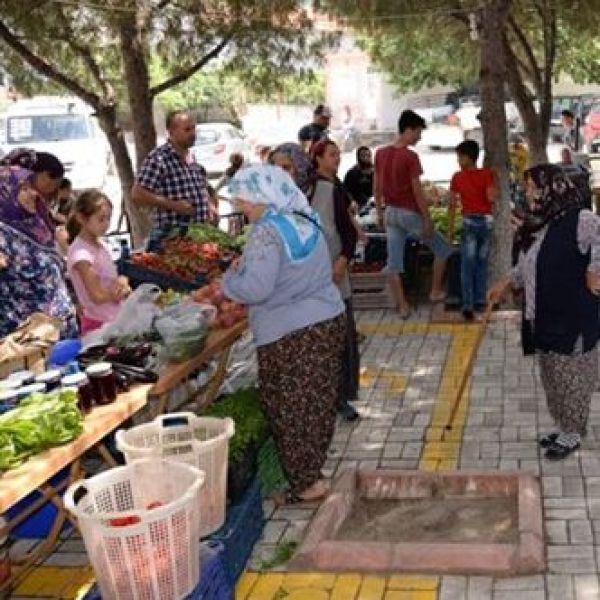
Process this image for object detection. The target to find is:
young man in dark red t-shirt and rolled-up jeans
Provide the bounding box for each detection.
[373,110,453,319]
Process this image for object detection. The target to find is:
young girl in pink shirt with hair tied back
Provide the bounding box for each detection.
[67,190,131,335]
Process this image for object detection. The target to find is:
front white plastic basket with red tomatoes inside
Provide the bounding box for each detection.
[64,459,204,600]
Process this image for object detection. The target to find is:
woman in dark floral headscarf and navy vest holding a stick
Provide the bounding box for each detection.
[488,164,600,460]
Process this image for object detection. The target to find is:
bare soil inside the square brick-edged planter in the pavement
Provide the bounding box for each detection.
[335,497,519,544]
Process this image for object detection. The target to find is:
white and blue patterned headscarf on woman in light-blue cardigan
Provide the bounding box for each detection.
[229,165,321,262]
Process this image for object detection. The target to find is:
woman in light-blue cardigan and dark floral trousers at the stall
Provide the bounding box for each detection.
[223,165,345,503]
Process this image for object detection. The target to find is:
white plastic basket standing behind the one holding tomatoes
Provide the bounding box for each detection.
[116,413,234,537]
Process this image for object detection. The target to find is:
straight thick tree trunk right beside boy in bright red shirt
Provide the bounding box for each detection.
[480,0,512,281]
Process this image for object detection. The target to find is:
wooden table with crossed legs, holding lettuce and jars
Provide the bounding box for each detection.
[0,385,150,596]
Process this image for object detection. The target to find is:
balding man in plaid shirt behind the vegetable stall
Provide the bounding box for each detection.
[131,111,218,240]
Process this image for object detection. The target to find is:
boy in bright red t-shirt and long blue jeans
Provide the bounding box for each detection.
[450,140,498,321]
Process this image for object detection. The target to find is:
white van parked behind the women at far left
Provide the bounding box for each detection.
[0,96,112,190]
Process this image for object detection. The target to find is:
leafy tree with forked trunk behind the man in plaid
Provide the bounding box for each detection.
[0,0,330,240]
